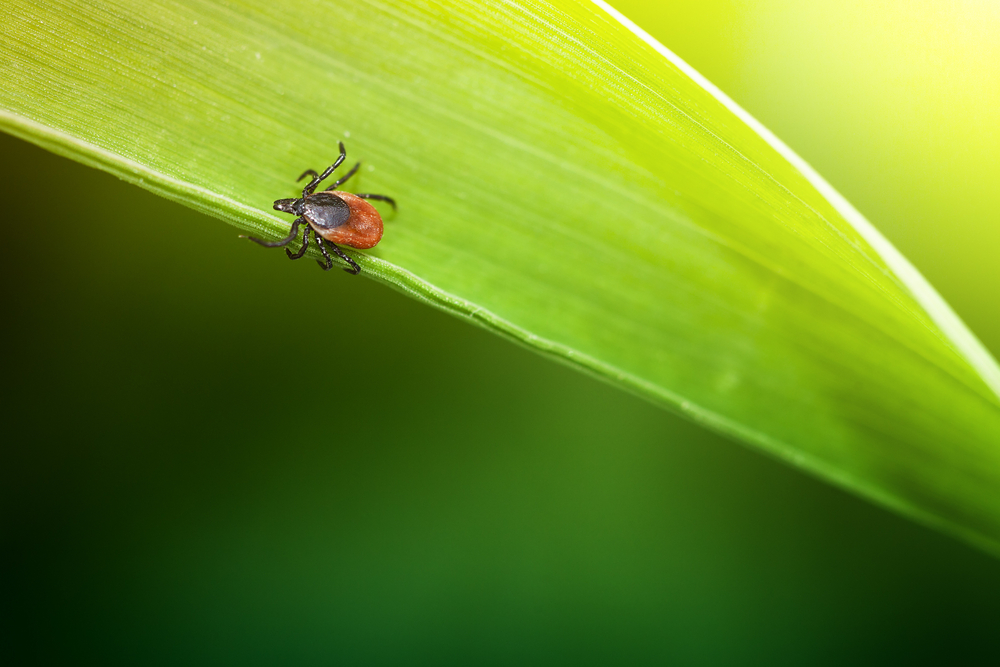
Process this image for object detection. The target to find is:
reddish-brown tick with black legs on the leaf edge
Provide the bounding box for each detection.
[244,141,396,276]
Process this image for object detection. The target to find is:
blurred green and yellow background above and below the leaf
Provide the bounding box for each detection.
[0,0,1000,665]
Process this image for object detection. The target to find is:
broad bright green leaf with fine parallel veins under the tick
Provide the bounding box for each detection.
[0,0,1000,553]
